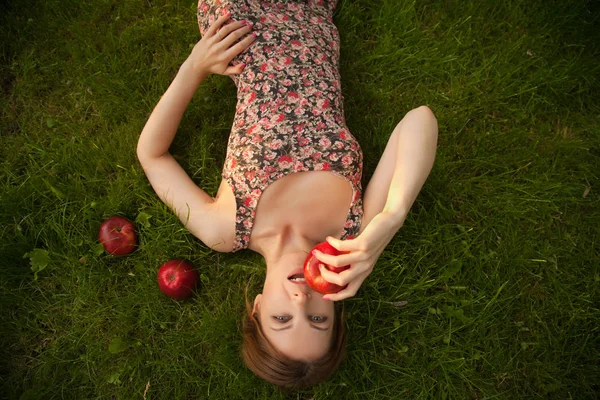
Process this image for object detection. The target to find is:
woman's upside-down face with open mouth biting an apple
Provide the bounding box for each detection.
[254,264,334,361]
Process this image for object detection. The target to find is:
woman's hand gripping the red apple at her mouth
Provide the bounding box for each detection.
[314,212,401,301]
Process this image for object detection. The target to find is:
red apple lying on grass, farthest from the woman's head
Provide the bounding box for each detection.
[98,216,137,256]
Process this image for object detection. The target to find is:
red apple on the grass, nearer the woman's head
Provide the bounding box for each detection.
[158,260,198,300]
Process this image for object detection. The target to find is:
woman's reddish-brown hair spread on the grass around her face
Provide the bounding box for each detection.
[242,293,347,389]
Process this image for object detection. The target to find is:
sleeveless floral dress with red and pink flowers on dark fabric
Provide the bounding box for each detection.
[198,0,363,251]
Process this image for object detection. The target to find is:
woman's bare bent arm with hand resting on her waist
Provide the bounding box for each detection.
[137,16,254,251]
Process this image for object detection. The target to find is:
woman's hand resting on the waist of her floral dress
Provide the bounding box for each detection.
[187,14,256,77]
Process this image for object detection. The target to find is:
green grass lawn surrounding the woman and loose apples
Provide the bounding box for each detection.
[0,0,600,399]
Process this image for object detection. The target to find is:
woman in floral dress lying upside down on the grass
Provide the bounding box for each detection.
[137,0,437,388]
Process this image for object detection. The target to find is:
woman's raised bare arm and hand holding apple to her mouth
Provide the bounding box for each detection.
[316,107,438,300]
